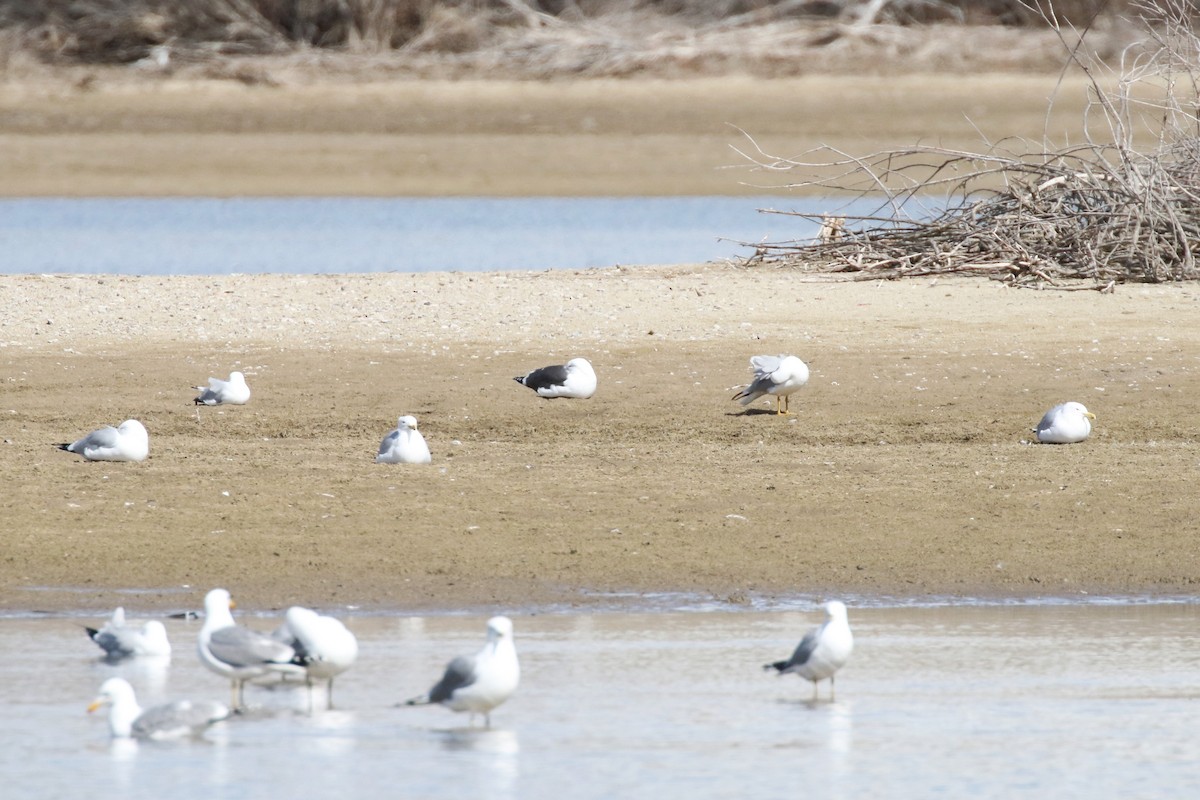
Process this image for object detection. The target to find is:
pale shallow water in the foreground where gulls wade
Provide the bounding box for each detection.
[0,603,1200,800]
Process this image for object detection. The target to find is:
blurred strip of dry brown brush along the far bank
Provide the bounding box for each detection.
[0,0,1142,78]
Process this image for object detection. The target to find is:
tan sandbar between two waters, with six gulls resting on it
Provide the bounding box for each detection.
[0,265,1200,610]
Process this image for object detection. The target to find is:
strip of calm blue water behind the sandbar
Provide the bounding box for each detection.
[0,197,868,275]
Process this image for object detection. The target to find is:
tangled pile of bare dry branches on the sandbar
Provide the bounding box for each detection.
[748,0,1200,290]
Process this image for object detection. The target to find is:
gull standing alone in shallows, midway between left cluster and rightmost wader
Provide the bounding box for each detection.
[404,616,521,728]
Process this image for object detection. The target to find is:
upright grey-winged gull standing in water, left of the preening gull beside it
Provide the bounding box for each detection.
[197,589,305,710]
